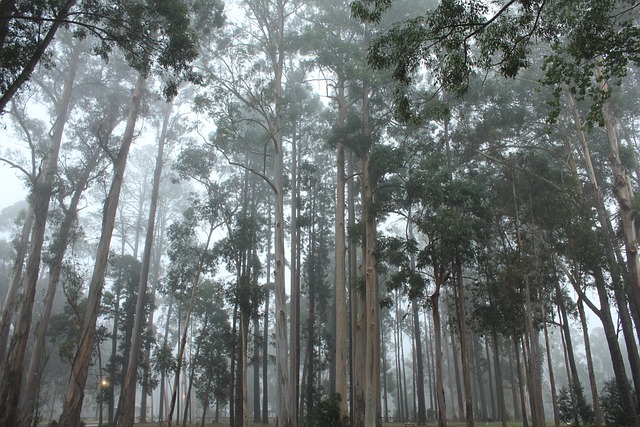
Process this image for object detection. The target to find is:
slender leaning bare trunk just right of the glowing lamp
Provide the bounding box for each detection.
[117,102,173,427]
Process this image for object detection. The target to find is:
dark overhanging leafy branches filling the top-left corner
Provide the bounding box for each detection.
[0,0,224,106]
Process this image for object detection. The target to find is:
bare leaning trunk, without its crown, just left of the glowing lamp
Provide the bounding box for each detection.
[60,75,146,427]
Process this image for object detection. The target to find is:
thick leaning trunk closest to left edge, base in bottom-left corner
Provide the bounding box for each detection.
[0,40,81,426]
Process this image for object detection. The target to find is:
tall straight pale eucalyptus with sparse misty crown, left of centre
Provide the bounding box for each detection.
[199,0,301,427]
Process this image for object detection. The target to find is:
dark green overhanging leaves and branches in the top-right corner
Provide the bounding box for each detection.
[352,0,640,124]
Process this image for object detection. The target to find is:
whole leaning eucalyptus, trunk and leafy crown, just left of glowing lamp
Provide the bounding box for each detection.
[60,0,197,426]
